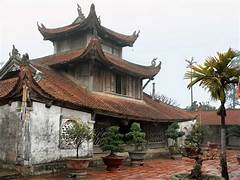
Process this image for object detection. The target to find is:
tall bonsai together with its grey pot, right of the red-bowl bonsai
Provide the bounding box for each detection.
[125,122,146,166]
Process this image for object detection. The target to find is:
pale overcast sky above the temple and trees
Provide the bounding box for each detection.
[0,0,240,107]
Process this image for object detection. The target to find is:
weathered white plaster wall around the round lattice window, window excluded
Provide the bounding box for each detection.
[30,102,93,164]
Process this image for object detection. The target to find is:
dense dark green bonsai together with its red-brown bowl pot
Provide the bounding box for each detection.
[100,126,125,171]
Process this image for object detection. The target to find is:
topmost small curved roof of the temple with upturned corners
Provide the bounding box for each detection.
[38,4,139,47]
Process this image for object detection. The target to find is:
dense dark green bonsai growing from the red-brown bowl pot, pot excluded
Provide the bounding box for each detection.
[100,126,124,156]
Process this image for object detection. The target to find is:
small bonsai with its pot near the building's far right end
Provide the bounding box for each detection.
[165,122,185,159]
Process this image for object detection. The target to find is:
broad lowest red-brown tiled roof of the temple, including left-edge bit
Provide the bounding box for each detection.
[0,66,193,122]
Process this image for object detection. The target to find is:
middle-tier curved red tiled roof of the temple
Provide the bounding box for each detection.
[31,38,161,78]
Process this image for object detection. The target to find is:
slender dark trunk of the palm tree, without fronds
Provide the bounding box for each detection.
[220,103,229,180]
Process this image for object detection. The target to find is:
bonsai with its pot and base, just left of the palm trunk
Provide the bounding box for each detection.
[185,123,204,179]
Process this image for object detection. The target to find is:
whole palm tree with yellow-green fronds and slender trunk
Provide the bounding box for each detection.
[185,49,240,180]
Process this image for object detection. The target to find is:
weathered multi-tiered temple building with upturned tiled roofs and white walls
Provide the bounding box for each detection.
[0,4,193,172]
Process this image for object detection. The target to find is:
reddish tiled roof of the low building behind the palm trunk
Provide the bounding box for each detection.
[194,109,240,125]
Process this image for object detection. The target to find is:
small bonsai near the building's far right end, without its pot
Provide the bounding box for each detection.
[165,122,185,151]
